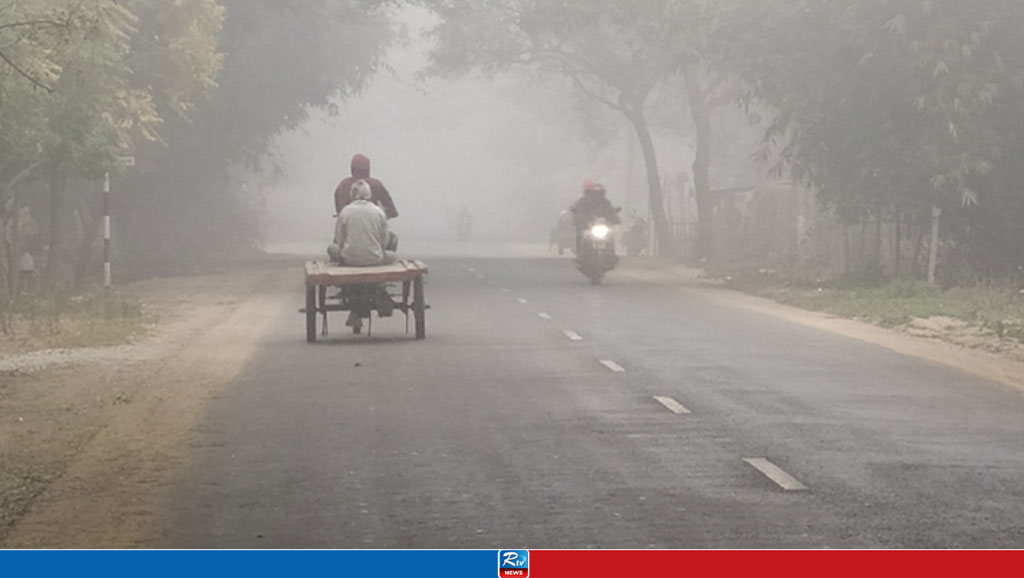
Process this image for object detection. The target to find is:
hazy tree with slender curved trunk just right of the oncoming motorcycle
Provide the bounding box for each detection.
[430,0,692,253]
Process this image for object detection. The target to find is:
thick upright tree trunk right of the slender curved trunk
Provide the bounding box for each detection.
[684,67,715,258]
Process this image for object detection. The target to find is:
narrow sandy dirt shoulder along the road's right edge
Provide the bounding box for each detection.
[618,259,1024,389]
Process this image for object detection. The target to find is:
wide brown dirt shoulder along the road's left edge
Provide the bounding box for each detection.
[0,263,297,547]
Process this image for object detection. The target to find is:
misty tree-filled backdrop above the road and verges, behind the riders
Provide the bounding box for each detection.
[0,0,1024,297]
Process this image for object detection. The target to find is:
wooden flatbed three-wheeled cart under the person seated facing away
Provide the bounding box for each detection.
[299,260,428,343]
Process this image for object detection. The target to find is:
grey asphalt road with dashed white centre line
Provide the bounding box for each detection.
[161,242,1024,548]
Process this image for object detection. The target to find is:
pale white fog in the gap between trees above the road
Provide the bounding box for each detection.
[266,7,683,253]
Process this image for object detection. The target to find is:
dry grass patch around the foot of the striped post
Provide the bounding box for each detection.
[0,292,152,353]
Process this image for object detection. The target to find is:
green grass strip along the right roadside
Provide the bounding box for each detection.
[713,267,1024,342]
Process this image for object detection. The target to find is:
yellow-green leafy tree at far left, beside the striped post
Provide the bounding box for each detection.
[0,0,154,284]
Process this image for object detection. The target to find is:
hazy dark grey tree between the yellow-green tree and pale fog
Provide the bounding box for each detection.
[118,0,391,272]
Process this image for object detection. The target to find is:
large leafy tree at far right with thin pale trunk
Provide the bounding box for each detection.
[745,0,1024,280]
